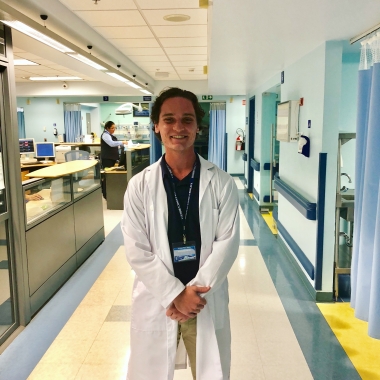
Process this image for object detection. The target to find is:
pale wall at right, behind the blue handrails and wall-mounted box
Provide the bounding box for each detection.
[249,42,348,292]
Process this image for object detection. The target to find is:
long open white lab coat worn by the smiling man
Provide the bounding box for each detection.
[121,157,240,380]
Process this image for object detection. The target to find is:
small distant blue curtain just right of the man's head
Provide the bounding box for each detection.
[208,103,227,170]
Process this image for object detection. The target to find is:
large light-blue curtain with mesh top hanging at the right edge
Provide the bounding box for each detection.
[351,39,380,339]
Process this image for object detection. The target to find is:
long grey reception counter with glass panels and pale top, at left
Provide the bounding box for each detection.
[23,160,104,315]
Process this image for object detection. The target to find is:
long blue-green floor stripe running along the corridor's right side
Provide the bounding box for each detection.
[239,190,360,380]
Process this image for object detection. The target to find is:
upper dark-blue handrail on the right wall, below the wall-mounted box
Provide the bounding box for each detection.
[274,177,317,220]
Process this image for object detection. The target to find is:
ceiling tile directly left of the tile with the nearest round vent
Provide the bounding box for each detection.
[75,11,146,26]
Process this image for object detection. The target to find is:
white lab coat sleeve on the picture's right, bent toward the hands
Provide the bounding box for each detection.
[189,178,240,294]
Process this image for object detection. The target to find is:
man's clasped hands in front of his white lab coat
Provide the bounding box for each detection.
[166,285,211,322]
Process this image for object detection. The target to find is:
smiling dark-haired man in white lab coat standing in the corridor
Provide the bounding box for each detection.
[122,88,240,380]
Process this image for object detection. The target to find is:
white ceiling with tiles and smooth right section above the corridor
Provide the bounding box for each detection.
[0,0,380,95]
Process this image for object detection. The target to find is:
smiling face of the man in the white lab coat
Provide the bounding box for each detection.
[154,97,198,152]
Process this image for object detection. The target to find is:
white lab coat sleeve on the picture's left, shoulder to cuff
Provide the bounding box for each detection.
[121,178,185,308]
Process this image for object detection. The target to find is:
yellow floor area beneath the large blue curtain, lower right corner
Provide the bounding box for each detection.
[317,303,380,380]
